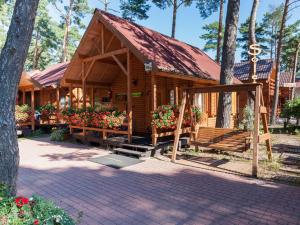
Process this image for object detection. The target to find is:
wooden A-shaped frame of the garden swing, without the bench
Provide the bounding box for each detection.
[172,83,272,177]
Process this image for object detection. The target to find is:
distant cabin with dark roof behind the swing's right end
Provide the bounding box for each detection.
[234,59,275,118]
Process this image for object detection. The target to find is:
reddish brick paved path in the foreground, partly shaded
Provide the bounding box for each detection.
[18,138,300,225]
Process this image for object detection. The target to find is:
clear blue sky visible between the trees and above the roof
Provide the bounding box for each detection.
[50,0,300,61]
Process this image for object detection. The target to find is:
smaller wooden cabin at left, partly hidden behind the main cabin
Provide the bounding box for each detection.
[17,62,86,124]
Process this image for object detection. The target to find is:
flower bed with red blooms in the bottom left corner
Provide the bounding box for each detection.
[0,193,75,225]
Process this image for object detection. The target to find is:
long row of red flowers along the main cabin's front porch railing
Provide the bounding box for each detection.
[62,108,126,129]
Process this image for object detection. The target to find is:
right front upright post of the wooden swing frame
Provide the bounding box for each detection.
[252,85,261,177]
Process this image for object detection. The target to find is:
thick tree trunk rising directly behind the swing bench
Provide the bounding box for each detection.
[216,0,240,127]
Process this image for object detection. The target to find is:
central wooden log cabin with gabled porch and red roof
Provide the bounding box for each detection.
[61,9,240,144]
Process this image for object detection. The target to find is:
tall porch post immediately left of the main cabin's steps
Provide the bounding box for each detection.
[127,50,132,143]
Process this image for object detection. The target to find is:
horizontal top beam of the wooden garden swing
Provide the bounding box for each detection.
[187,83,262,93]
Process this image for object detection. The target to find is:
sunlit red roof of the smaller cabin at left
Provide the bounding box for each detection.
[31,62,69,87]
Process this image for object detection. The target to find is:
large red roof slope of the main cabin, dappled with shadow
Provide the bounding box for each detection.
[96,10,221,81]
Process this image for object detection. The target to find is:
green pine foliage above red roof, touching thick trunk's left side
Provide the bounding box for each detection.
[200,21,224,57]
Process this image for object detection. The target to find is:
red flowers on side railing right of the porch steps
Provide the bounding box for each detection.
[151,105,202,131]
